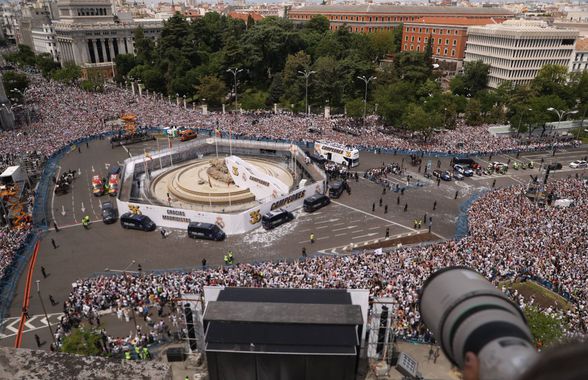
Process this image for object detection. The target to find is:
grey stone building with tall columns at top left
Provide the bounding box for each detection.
[53,0,163,75]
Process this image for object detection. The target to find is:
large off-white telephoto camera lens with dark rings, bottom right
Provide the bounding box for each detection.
[420,267,536,380]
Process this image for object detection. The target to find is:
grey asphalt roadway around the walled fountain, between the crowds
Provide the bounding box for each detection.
[0,139,588,348]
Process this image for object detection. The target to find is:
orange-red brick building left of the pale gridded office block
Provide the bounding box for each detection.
[401,17,503,72]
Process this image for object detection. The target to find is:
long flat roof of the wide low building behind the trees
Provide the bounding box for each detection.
[290,4,514,16]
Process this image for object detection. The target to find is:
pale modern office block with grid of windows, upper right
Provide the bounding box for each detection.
[465,20,578,88]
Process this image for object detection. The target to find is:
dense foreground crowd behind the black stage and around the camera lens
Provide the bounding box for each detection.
[68,179,588,339]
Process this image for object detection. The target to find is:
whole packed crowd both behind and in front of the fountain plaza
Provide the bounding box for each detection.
[0,77,588,348]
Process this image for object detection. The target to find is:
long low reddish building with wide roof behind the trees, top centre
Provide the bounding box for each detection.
[287,4,514,33]
